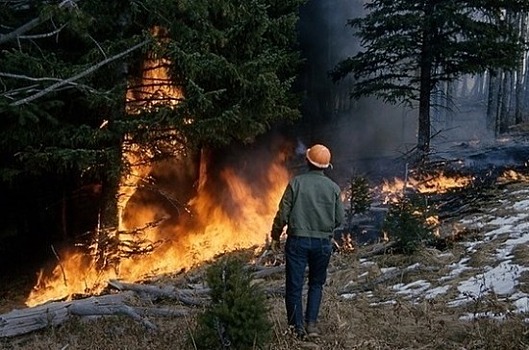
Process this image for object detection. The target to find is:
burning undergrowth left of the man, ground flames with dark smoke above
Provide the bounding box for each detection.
[27,138,290,306]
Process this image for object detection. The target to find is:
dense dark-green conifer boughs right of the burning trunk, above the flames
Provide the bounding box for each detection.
[141,0,303,144]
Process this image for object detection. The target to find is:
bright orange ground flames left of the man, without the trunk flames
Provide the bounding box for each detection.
[26,150,290,306]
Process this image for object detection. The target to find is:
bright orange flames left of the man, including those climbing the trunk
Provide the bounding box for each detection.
[26,29,290,306]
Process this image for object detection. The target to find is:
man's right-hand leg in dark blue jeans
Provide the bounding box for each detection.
[305,238,332,324]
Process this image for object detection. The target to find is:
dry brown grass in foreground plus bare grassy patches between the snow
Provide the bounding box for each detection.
[0,250,529,350]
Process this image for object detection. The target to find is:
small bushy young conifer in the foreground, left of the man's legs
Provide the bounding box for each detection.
[193,258,272,350]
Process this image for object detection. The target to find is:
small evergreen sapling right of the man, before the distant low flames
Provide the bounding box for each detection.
[383,195,435,254]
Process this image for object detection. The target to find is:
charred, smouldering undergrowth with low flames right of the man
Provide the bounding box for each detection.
[336,161,528,249]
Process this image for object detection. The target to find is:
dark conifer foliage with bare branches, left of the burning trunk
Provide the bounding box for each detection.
[0,0,146,184]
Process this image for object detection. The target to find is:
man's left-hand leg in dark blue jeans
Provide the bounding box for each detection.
[285,236,310,331]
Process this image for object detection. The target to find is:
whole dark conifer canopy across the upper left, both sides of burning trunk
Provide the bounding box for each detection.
[0,0,303,243]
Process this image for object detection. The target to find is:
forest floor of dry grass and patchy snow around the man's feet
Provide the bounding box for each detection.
[0,181,529,350]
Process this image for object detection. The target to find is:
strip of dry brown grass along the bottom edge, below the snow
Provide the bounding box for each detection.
[0,288,529,350]
